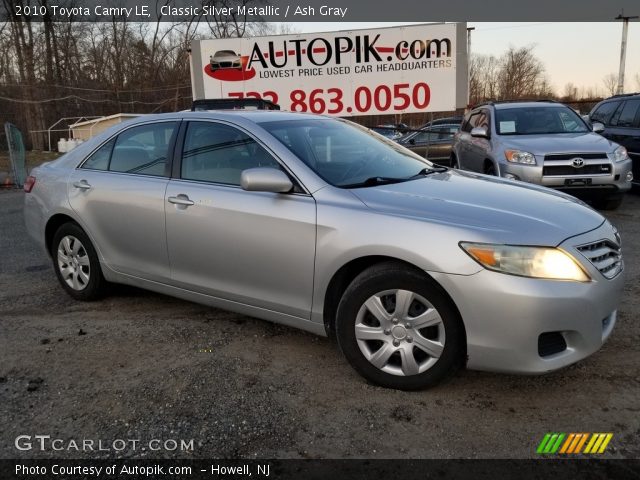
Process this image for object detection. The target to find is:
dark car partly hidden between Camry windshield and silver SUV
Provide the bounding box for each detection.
[398,123,460,166]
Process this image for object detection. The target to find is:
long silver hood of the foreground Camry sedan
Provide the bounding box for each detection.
[351,170,605,246]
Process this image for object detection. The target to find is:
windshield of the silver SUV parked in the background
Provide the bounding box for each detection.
[496,106,589,135]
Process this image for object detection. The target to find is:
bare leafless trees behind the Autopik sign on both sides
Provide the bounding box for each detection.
[0,11,640,150]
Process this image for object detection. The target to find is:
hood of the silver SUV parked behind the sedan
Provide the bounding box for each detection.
[500,132,618,155]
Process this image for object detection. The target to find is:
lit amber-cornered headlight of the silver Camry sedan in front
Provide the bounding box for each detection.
[460,242,591,282]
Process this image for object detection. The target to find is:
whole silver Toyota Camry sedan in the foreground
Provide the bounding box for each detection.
[25,111,623,390]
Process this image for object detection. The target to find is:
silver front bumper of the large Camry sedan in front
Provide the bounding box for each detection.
[429,222,624,374]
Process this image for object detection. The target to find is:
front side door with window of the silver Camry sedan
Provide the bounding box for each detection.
[165,121,316,319]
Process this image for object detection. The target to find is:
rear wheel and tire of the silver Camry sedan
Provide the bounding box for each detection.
[51,223,107,301]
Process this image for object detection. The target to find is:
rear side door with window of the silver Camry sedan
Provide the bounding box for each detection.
[68,121,179,282]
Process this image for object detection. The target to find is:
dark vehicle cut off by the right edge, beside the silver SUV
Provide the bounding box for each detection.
[589,92,640,189]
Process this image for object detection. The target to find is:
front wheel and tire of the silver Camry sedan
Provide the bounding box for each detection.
[336,263,466,390]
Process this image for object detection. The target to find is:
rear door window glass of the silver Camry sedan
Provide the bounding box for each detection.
[109,122,176,176]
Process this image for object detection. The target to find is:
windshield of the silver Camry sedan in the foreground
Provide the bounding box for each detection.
[260,118,440,188]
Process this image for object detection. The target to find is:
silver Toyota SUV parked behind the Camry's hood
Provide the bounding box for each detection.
[451,101,633,209]
